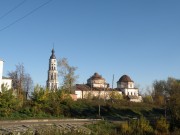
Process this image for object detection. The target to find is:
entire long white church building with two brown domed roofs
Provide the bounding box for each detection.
[75,73,142,102]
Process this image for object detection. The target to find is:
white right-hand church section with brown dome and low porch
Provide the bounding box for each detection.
[117,75,142,102]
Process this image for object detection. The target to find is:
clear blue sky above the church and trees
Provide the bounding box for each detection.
[0,0,180,93]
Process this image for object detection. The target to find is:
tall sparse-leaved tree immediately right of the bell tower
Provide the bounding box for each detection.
[58,58,78,91]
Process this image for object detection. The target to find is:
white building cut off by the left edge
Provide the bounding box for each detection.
[0,60,12,92]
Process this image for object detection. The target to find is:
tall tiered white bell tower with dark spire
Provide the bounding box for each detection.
[46,48,59,90]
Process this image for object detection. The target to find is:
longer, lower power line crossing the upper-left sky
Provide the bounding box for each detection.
[0,0,53,32]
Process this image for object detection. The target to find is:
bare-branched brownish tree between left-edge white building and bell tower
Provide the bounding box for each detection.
[8,64,33,99]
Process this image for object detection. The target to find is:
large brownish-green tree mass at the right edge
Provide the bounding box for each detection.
[154,78,180,129]
